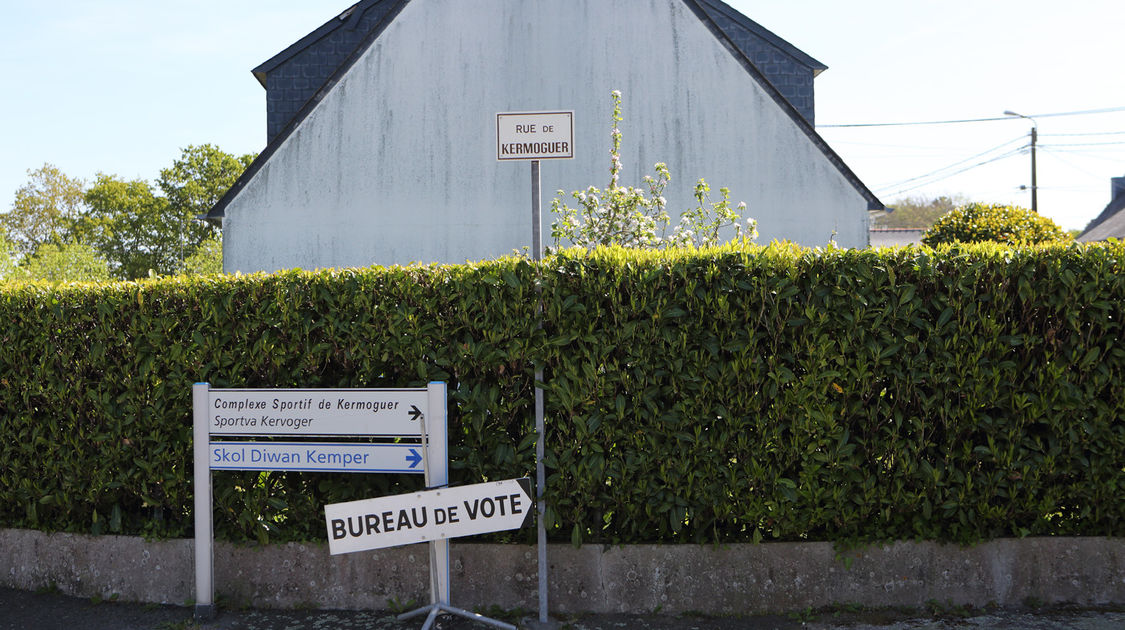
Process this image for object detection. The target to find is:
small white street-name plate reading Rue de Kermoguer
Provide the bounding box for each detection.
[496,111,574,160]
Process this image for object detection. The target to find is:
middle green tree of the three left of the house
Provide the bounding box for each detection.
[73,173,180,280]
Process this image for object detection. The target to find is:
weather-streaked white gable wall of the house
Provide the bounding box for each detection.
[223,0,867,271]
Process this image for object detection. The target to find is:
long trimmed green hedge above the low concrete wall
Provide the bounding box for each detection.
[0,244,1125,542]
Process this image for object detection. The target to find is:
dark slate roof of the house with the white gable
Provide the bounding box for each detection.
[203,0,884,221]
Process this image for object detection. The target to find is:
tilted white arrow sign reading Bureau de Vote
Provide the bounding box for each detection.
[324,478,534,555]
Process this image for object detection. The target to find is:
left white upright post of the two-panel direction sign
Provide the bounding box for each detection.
[191,383,215,621]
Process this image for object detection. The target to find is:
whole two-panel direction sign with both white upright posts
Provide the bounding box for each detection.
[191,383,450,620]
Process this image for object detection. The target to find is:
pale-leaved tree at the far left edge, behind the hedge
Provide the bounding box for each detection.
[0,164,84,255]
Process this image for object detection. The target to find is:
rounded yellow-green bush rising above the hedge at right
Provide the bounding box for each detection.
[921,204,1072,246]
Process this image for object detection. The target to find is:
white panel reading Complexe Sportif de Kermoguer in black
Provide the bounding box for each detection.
[206,389,428,438]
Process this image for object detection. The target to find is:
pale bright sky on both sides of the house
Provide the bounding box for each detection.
[0,0,1125,228]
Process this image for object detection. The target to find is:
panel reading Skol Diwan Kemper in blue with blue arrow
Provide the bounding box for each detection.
[208,442,423,475]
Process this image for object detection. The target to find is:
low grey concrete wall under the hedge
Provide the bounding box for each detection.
[0,530,1125,614]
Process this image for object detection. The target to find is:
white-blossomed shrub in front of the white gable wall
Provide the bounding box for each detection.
[551,90,758,249]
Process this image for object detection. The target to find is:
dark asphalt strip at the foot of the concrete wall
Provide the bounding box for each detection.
[0,588,1125,630]
